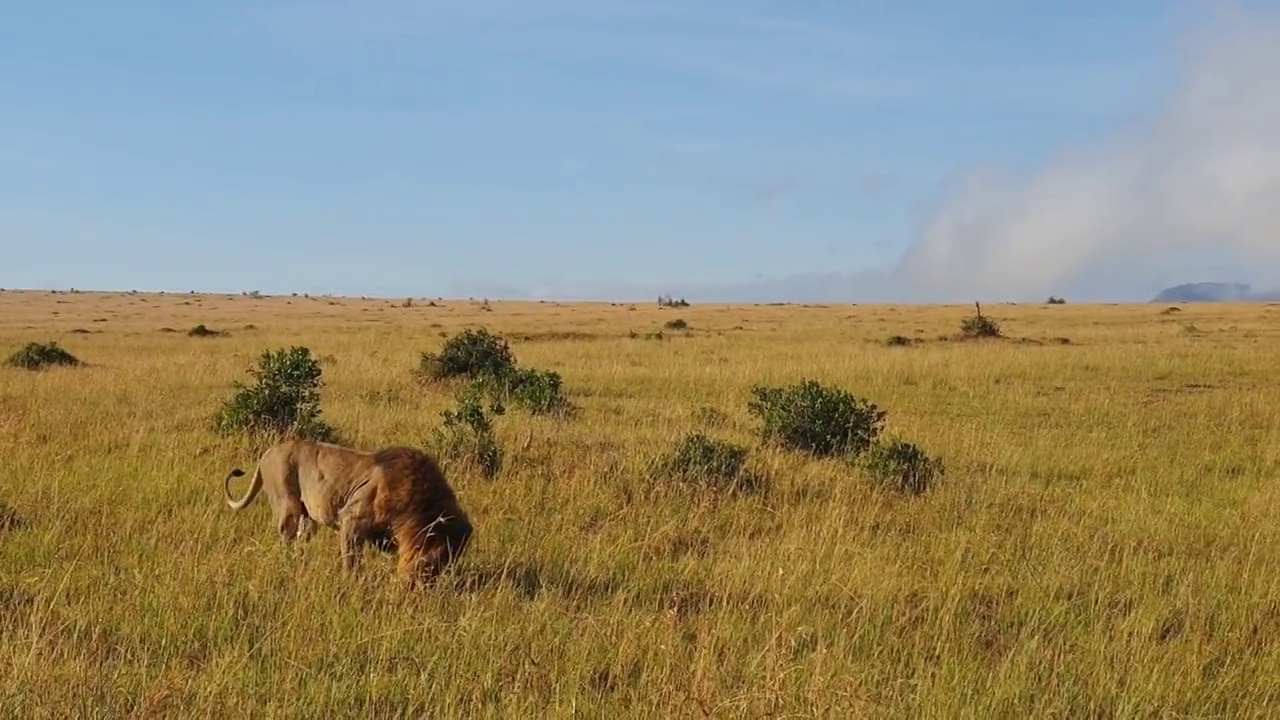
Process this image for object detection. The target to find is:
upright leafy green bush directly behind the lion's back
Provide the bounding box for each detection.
[214,346,337,441]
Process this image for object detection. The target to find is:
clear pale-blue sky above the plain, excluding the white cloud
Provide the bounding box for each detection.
[0,0,1274,300]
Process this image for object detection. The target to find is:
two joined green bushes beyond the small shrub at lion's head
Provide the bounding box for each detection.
[415,328,573,415]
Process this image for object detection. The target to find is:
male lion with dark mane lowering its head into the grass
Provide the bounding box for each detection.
[223,439,472,584]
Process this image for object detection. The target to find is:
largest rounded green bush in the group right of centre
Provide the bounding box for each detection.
[748,380,886,457]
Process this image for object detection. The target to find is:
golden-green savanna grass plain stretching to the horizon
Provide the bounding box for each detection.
[0,291,1280,717]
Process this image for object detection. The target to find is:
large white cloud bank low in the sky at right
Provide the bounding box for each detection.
[893,2,1280,300]
